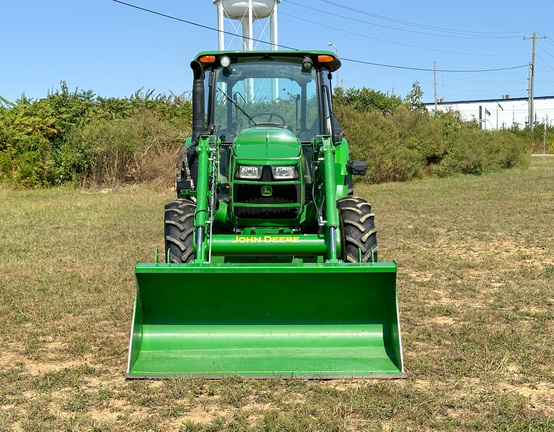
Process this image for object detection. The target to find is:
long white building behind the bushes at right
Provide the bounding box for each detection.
[425,96,554,129]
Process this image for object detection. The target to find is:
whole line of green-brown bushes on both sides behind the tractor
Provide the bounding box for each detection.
[0,82,536,187]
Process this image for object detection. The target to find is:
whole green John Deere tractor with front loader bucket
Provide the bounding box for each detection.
[127,51,404,378]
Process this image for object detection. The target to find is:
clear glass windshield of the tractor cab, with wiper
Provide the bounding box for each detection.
[208,59,319,142]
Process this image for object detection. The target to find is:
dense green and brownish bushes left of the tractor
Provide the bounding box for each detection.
[0,82,192,187]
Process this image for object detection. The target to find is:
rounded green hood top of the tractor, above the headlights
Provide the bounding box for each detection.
[233,127,301,165]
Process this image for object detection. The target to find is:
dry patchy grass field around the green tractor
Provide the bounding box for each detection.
[0,158,554,432]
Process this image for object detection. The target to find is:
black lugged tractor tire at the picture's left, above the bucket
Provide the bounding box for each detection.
[164,199,196,263]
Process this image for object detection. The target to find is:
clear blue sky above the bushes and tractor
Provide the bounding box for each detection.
[0,0,554,102]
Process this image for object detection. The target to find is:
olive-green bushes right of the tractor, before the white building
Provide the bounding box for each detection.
[335,104,529,183]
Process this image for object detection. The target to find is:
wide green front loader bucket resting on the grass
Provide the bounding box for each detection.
[127,263,404,378]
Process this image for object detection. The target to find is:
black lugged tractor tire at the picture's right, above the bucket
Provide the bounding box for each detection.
[338,196,378,262]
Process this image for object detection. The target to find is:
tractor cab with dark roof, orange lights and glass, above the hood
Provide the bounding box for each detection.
[192,51,340,144]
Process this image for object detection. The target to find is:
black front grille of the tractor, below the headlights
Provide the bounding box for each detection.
[233,183,301,219]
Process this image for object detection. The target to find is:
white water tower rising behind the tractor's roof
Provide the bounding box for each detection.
[213,0,281,51]
